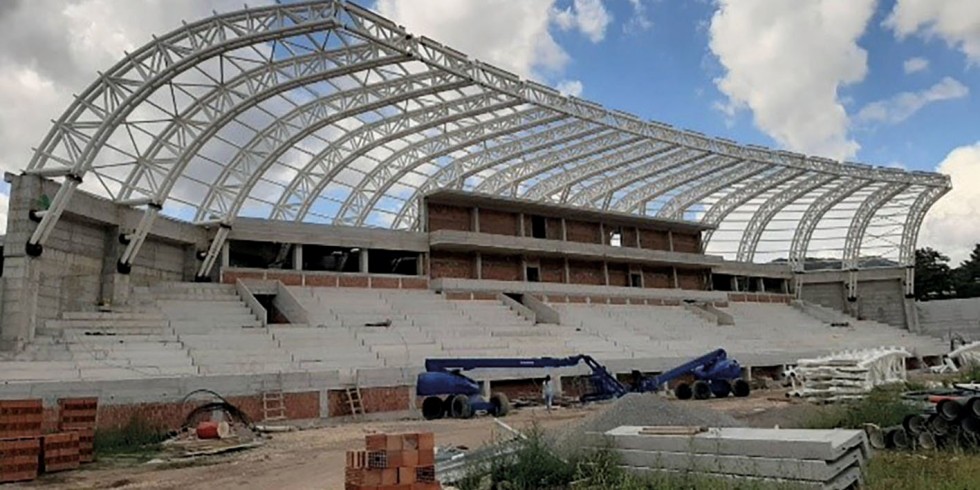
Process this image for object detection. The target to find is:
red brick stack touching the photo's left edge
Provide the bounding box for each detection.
[0,400,44,483]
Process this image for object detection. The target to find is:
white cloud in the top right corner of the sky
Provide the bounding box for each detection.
[884,0,980,63]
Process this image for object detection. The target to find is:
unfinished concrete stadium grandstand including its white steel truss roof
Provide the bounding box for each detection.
[0,1,950,420]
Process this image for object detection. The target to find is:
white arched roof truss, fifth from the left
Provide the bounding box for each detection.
[337,108,566,226]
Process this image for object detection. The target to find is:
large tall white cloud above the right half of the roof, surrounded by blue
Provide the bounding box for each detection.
[710,0,875,159]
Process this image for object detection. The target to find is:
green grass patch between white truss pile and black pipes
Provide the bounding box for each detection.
[804,386,921,429]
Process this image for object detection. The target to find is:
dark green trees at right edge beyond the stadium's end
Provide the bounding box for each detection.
[915,243,980,301]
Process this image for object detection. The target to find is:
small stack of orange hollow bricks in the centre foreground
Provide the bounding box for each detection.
[344,432,442,490]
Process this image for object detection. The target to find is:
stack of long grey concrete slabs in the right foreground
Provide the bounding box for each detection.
[605,426,870,489]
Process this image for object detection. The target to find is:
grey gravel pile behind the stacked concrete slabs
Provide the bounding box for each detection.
[554,393,745,458]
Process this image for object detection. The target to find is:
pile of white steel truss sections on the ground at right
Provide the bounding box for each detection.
[786,347,912,402]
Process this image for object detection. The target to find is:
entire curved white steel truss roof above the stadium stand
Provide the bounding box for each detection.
[26,1,950,280]
